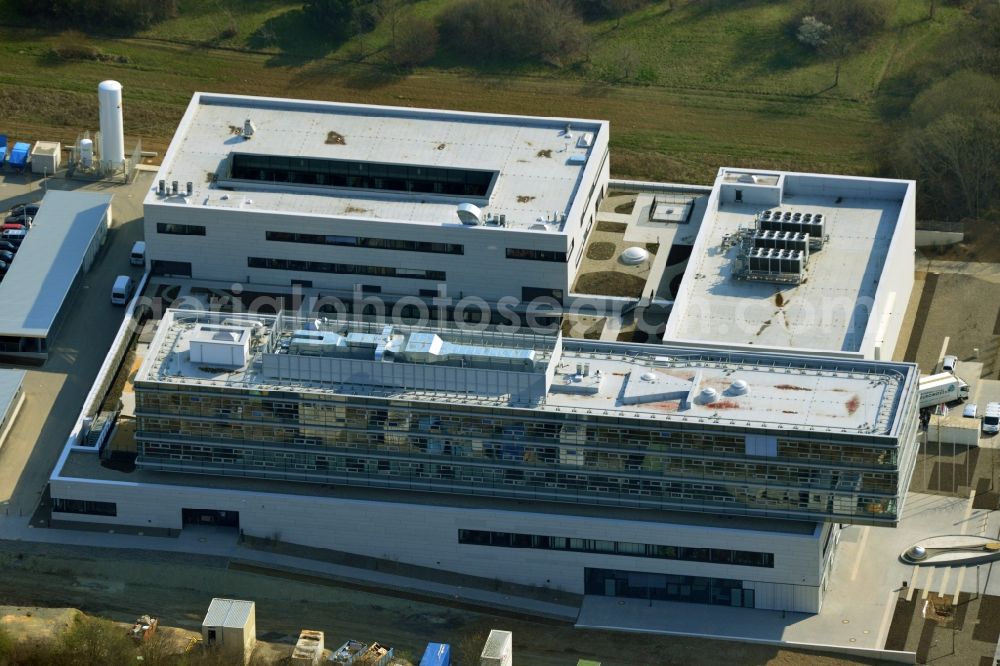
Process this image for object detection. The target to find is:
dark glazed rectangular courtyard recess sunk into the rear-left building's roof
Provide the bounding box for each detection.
[230,153,496,197]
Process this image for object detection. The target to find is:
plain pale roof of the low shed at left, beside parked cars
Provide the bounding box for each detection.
[0,190,111,338]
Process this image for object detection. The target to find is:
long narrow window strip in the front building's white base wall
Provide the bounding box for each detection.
[458,530,774,569]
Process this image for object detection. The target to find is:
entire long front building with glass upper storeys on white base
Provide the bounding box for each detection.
[50,310,918,612]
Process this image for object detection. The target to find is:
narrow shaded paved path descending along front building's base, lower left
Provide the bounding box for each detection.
[0,517,579,622]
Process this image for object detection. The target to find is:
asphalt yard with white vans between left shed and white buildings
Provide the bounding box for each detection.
[0,166,152,515]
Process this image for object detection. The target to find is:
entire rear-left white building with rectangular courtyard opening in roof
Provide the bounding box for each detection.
[144,93,608,302]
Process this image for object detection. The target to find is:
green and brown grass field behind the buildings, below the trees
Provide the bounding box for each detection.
[0,0,972,183]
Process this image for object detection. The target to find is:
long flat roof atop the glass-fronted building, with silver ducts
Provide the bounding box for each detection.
[135,310,919,436]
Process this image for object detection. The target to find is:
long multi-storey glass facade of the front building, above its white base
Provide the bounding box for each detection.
[136,383,916,524]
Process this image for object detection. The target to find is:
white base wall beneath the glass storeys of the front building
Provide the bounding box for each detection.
[51,478,822,612]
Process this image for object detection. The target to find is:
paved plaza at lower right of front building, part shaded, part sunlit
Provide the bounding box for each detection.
[577,493,1000,650]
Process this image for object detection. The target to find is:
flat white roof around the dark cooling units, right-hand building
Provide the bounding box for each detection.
[663,169,914,352]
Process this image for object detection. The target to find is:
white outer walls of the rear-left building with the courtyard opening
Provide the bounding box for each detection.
[144,141,610,308]
